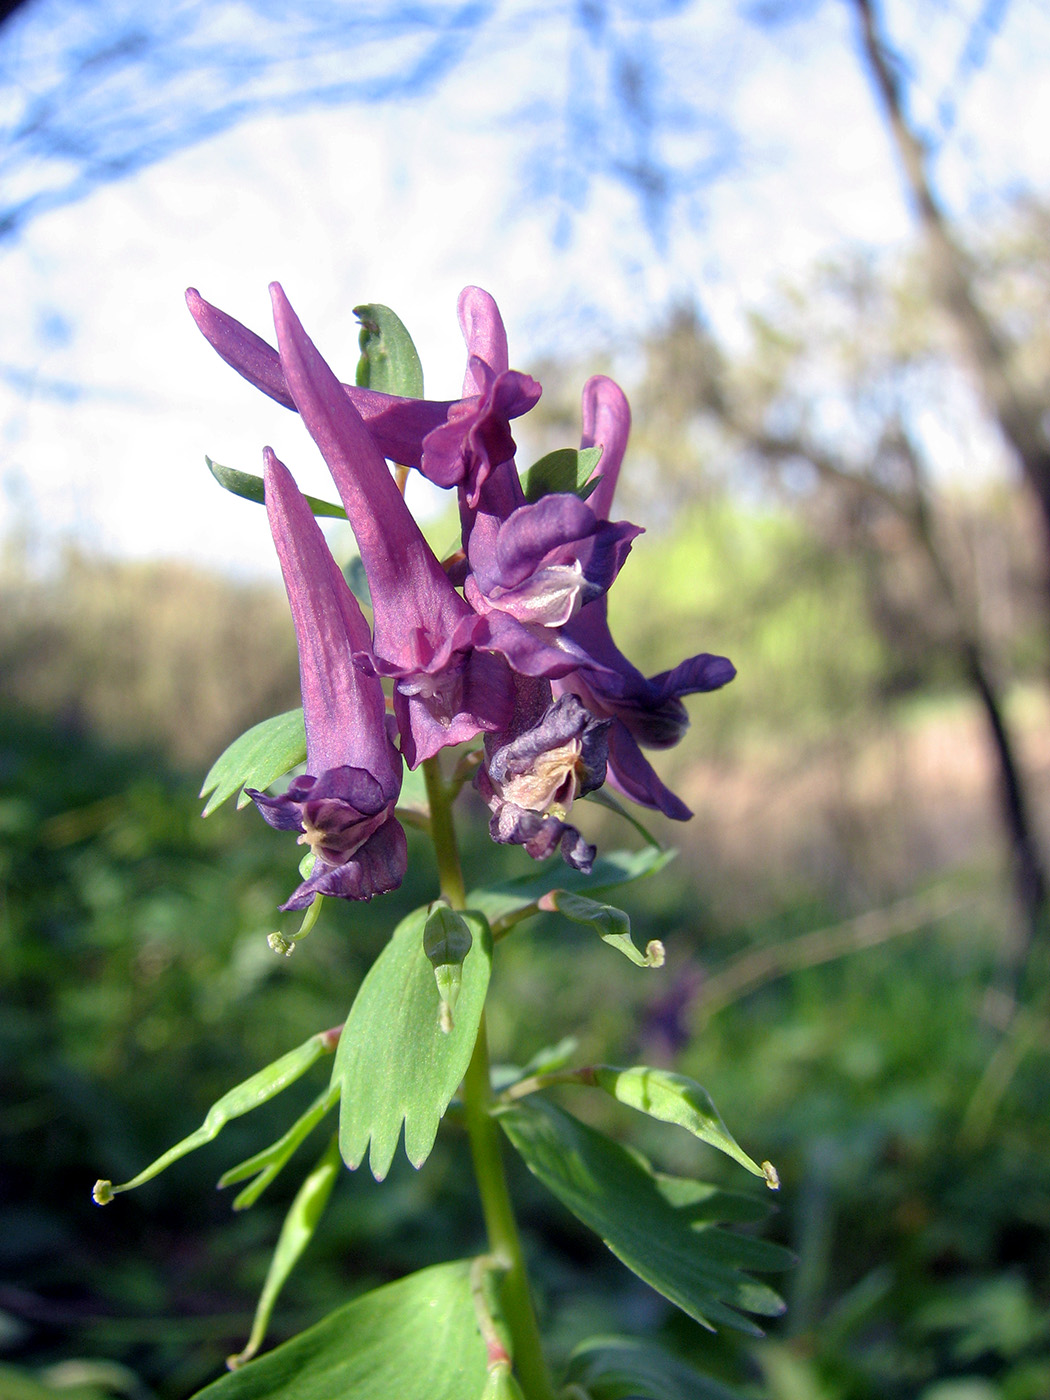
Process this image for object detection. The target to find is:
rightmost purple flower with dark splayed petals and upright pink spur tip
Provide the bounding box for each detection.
[554,375,736,822]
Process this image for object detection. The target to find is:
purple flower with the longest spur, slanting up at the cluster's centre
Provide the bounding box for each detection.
[270,283,512,767]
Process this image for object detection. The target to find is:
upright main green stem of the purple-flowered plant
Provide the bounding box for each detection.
[423,757,554,1400]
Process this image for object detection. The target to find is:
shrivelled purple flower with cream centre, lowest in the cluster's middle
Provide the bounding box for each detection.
[475,680,610,872]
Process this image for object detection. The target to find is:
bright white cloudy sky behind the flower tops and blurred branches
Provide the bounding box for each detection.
[0,0,1050,574]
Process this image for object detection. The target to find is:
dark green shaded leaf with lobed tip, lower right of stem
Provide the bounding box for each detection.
[498,1098,790,1336]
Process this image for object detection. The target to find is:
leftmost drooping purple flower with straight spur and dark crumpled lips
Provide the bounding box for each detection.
[248,448,407,910]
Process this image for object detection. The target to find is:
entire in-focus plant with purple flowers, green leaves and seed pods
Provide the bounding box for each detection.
[95,284,788,1400]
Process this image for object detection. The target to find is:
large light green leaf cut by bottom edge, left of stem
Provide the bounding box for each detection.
[197,1260,486,1400]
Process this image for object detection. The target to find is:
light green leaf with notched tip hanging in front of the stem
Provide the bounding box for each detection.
[332,907,491,1182]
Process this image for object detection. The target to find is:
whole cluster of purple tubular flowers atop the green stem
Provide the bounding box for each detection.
[186,283,735,909]
